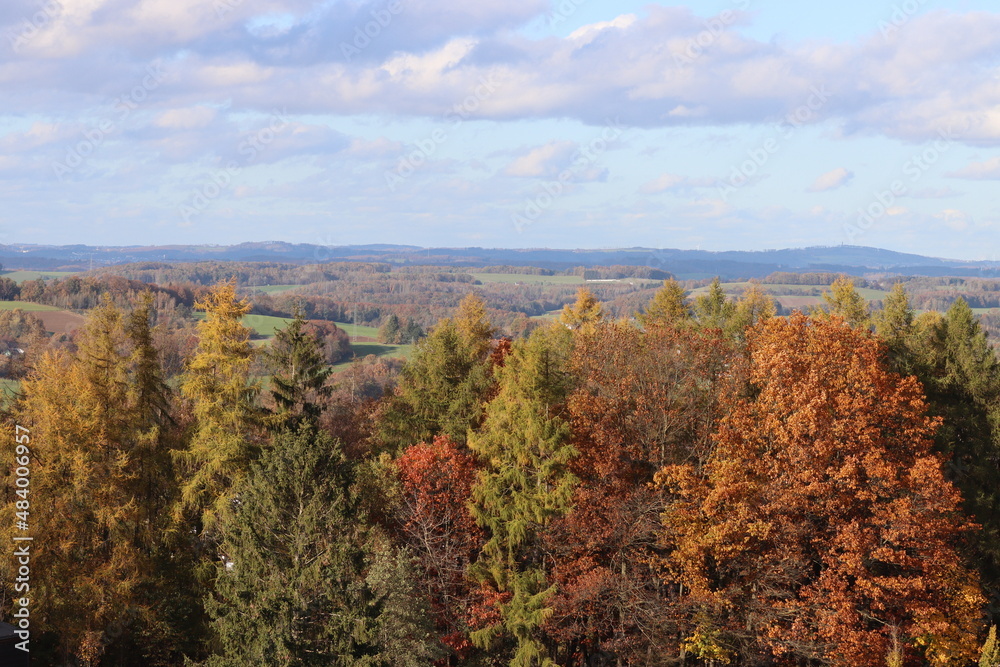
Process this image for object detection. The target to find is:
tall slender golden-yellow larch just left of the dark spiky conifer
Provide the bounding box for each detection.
[176,280,259,530]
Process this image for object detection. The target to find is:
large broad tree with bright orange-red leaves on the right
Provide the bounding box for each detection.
[659,314,982,665]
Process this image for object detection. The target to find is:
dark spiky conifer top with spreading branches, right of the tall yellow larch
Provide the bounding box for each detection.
[269,309,332,426]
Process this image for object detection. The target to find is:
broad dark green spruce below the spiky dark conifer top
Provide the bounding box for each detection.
[206,427,380,667]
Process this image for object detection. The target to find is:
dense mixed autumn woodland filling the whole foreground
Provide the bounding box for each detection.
[0,269,1000,667]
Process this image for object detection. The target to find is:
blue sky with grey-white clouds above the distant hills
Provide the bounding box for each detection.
[0,0,1000,260]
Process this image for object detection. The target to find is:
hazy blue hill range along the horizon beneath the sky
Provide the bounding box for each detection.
[0,241,1000,280]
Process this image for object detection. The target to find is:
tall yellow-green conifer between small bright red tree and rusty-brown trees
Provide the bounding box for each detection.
[469,327,576,667]
